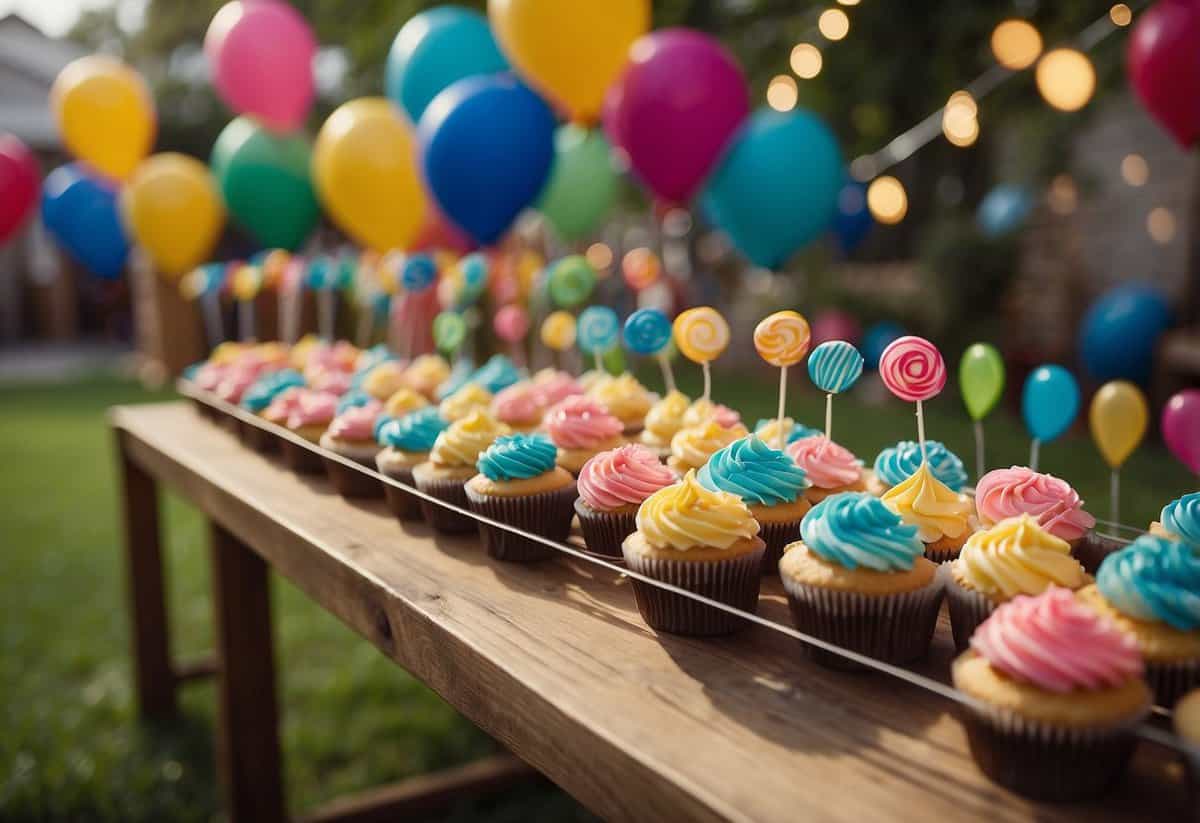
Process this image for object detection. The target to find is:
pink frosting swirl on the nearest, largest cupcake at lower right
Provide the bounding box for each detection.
[971,587,1142,692]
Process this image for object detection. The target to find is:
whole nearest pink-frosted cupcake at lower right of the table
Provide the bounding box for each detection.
[952,588,1150,801]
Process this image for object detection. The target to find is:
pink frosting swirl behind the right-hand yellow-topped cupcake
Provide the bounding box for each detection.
[976,465,1096,542]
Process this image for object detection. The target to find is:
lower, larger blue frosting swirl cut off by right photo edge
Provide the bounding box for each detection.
[1096,534,1200,631]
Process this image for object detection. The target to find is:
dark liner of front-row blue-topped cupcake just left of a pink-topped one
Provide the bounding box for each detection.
[466,483,576,563]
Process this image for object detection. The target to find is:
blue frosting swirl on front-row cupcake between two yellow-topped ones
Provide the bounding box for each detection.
[800,492,925,571]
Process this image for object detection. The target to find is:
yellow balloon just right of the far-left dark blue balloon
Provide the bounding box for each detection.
[121,151,224,278]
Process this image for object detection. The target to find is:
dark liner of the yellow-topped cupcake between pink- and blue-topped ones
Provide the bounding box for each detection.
[625,548,766,637]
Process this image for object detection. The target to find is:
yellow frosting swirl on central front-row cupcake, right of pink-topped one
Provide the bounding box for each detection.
[637,471,758,552]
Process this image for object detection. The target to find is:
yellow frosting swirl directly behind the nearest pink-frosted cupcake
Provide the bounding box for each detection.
[954,515,1085,600]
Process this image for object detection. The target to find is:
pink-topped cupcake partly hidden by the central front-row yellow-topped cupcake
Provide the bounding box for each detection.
[575,444,678,557]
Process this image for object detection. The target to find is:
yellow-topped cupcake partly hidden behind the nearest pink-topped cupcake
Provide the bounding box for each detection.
[942,515,1088,651]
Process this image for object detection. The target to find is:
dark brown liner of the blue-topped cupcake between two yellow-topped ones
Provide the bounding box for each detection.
[784,575,942,671]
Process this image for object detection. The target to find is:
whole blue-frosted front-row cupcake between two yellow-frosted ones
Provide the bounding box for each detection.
[779,492,942,669]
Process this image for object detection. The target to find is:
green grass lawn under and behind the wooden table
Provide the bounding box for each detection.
[0,374,1194,822]
